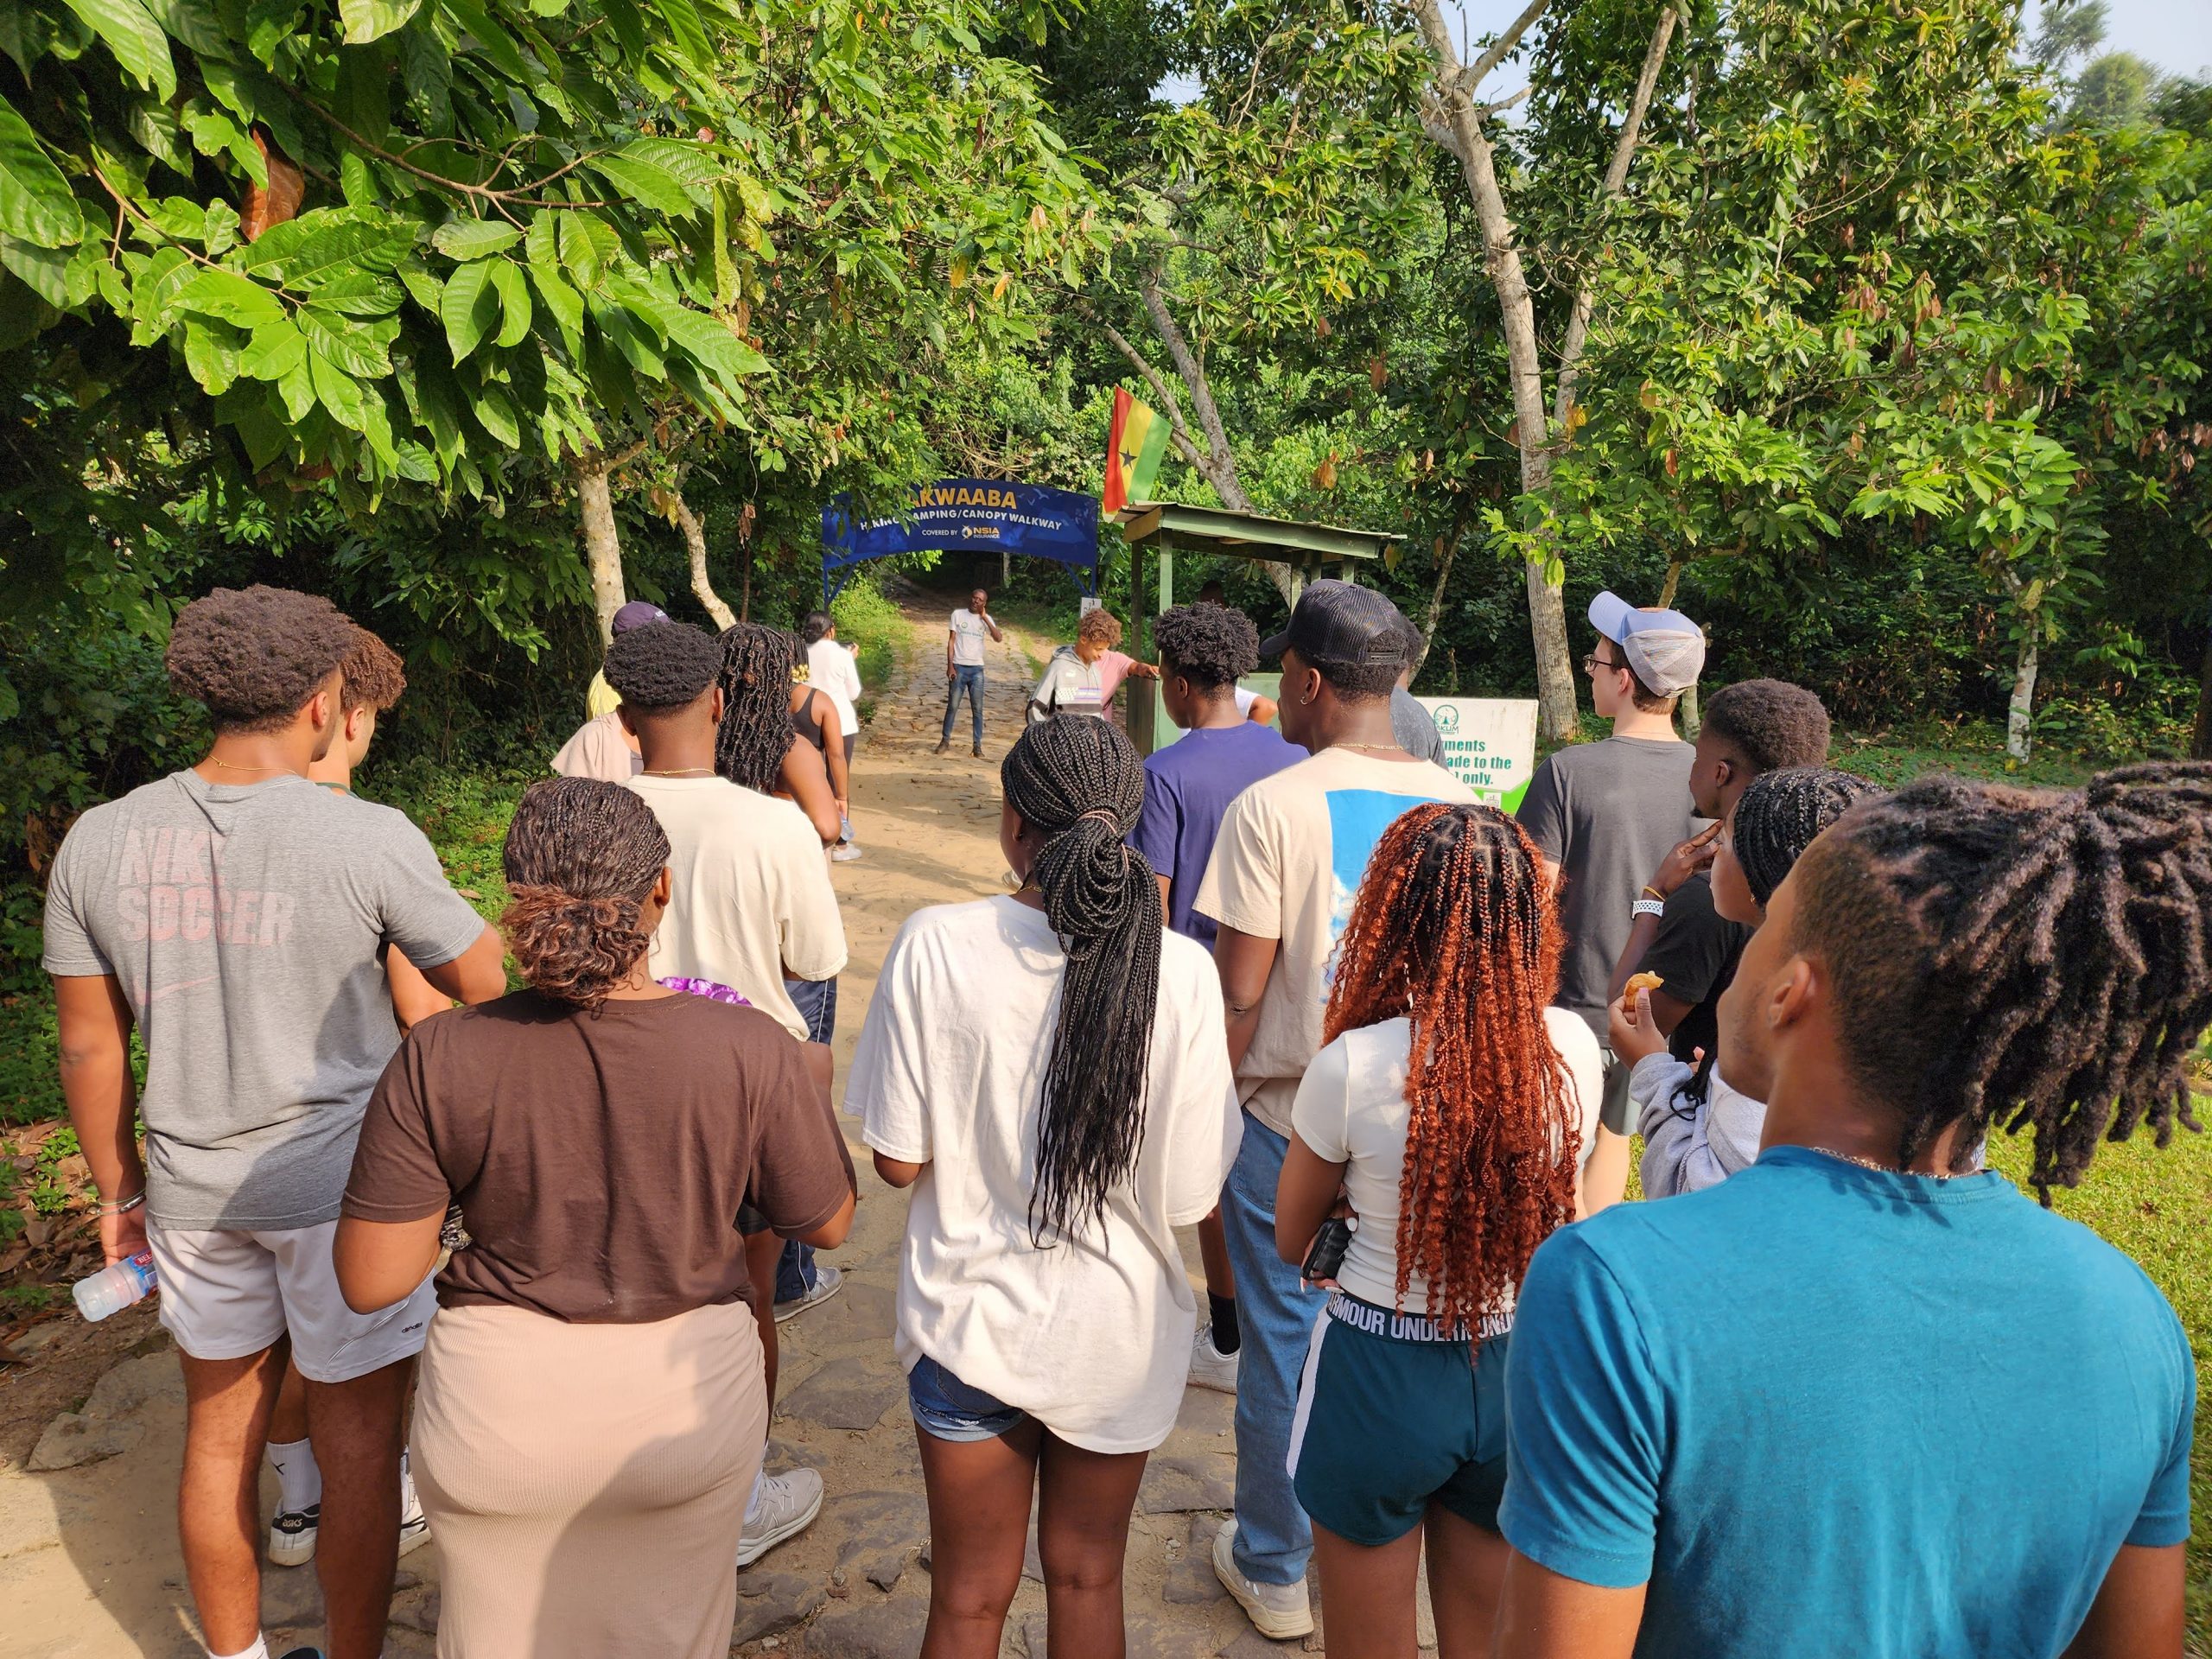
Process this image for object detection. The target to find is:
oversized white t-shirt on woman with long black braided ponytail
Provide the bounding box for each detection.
[845,898,1243,1453]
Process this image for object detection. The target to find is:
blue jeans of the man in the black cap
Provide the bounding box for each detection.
[1221,1113,1330,1584]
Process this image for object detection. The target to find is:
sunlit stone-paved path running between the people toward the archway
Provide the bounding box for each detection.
[0,593,1319,1659]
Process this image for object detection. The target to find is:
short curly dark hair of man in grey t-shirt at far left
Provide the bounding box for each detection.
[166,582,360,732]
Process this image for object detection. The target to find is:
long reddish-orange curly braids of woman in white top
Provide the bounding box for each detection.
[1327,803,1581,1330]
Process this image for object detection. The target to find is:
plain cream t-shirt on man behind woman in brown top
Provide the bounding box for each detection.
[631,774,845,1042]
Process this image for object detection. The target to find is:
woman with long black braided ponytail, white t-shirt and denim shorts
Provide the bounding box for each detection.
[845,719,1239,1659]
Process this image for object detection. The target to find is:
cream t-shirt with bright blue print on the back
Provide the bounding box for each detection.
[1194,747,1476,1135]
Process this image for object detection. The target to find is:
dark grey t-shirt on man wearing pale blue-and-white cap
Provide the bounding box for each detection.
[1520,736,1697,1042]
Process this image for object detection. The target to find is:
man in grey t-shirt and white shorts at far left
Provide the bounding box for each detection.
[44,586,506,1659]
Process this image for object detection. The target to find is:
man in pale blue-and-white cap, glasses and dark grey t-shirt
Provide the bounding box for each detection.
[1520,593,1706,1210]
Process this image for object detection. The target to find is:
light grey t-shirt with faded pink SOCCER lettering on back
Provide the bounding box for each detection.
[44,772,485,1230]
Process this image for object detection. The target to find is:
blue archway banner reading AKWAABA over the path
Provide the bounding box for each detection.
[823,478,1099,601]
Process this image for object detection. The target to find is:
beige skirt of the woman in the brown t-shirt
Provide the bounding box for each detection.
[410,1303,767,1659]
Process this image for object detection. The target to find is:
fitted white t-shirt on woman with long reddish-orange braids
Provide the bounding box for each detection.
[1289,1008,1606,1316]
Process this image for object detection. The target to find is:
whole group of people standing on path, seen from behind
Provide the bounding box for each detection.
[47,582,2212,1659]
